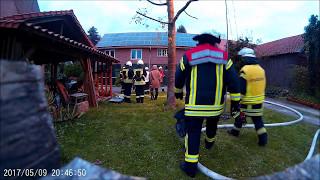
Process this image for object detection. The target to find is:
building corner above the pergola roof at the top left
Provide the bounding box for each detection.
[0,0,40,17]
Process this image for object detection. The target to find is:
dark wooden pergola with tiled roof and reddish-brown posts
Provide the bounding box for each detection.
[0,10,118,107]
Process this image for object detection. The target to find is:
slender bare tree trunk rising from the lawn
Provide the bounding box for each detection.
[167,0,176,108]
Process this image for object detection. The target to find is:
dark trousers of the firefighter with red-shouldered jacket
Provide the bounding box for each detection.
[185,116,220,168]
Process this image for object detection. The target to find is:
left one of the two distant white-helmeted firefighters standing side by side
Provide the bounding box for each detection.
[120,61,133,103]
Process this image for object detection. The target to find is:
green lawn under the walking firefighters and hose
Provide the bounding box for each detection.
[55,93,316,179]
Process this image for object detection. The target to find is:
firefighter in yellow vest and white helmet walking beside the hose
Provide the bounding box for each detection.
[228,48,268,146]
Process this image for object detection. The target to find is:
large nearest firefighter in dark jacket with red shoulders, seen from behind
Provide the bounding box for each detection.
[175,34,240,177]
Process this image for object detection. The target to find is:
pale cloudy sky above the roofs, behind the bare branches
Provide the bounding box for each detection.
[38,0,320,43]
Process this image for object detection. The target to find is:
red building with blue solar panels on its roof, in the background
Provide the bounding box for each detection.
[96,32,226,81]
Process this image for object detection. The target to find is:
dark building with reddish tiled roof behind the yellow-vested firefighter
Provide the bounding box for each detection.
[255,35,307,88]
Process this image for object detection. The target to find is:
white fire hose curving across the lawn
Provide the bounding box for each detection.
[179,101,320,179]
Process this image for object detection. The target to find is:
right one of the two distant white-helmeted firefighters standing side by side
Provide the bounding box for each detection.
[133,59,147,103]
